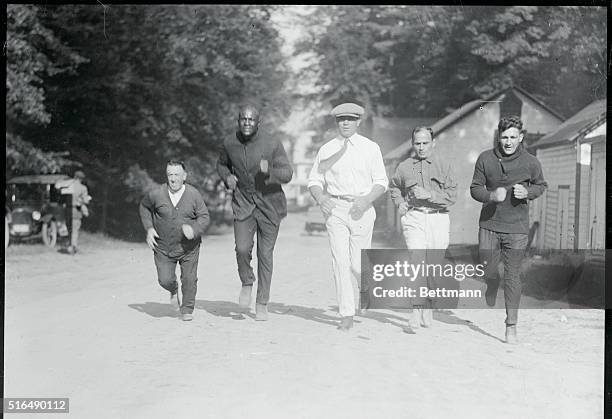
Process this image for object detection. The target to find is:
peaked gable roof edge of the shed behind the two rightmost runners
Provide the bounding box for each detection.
[383,86,565,160]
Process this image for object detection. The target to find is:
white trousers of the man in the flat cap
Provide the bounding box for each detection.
[325,198,376,317]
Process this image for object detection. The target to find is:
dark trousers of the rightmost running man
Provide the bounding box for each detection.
[478,228,527,326]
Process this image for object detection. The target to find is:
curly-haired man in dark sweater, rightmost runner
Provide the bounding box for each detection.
[470,116,547,343]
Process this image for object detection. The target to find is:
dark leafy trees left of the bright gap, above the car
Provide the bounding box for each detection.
[7,4,287,235]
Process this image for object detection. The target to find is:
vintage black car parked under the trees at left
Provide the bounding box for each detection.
[5,174,70,247]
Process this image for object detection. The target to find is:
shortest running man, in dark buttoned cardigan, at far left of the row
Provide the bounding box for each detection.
[140,160,210,321]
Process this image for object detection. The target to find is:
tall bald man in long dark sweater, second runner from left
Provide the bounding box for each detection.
[217,105,293,320]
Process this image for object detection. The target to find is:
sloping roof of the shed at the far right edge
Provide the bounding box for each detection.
[531,99,606,148]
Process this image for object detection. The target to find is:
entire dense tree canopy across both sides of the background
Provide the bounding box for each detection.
[6,3,607,240]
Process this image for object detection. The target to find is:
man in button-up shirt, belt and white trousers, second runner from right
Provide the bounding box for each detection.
[389,127,457,327]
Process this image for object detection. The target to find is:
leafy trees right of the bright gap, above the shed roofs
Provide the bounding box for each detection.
[298,5,606,120]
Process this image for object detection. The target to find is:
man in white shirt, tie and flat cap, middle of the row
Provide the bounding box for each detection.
[308,101,389,331]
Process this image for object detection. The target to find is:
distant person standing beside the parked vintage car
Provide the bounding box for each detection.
[55,170,91,255]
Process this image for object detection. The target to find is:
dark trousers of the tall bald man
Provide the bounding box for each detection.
[234,208,280,304]
